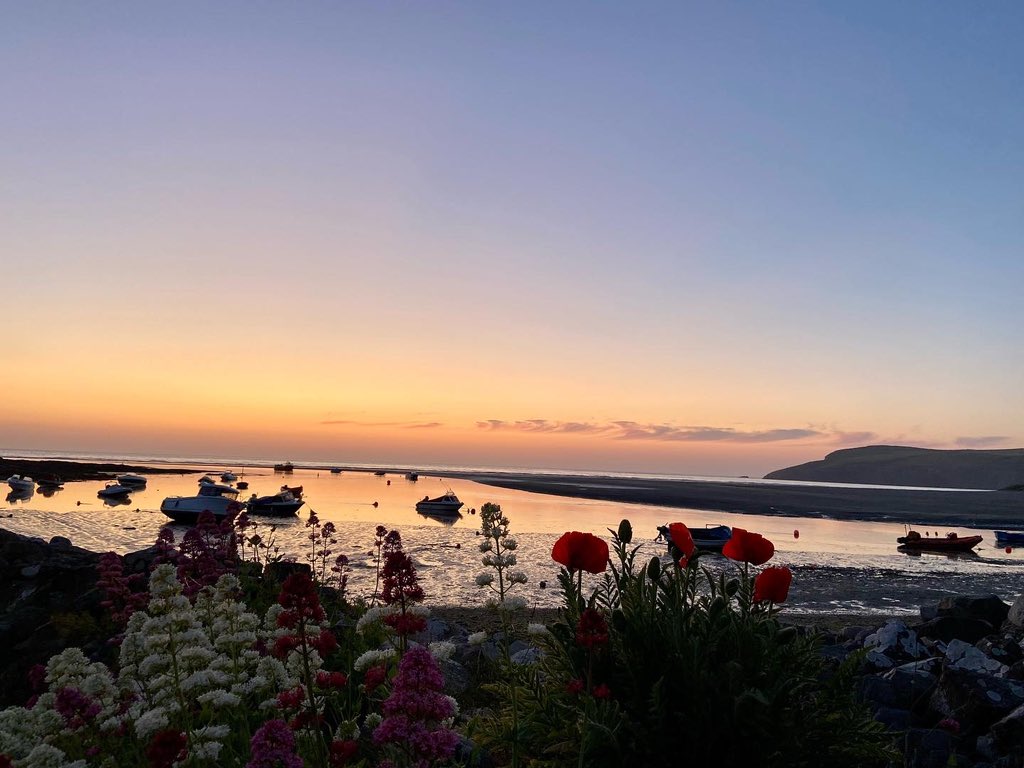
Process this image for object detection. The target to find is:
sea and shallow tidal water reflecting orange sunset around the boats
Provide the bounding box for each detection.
[0,449,1024,617]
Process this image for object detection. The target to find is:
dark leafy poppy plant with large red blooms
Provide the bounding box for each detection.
[507,520,889,767]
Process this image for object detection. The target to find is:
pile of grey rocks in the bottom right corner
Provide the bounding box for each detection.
[823,595,1024,768]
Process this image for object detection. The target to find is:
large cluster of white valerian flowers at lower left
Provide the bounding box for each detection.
[0,564,313,768]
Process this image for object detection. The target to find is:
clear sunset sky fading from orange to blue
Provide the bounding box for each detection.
[0,0,1024,476]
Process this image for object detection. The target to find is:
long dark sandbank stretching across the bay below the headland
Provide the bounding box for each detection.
[446,472,1024,529]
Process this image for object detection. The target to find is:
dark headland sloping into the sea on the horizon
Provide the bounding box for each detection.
[765,445,1024,490]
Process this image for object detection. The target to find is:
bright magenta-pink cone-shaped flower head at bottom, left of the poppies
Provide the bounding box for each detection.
[374,647,459,768]
